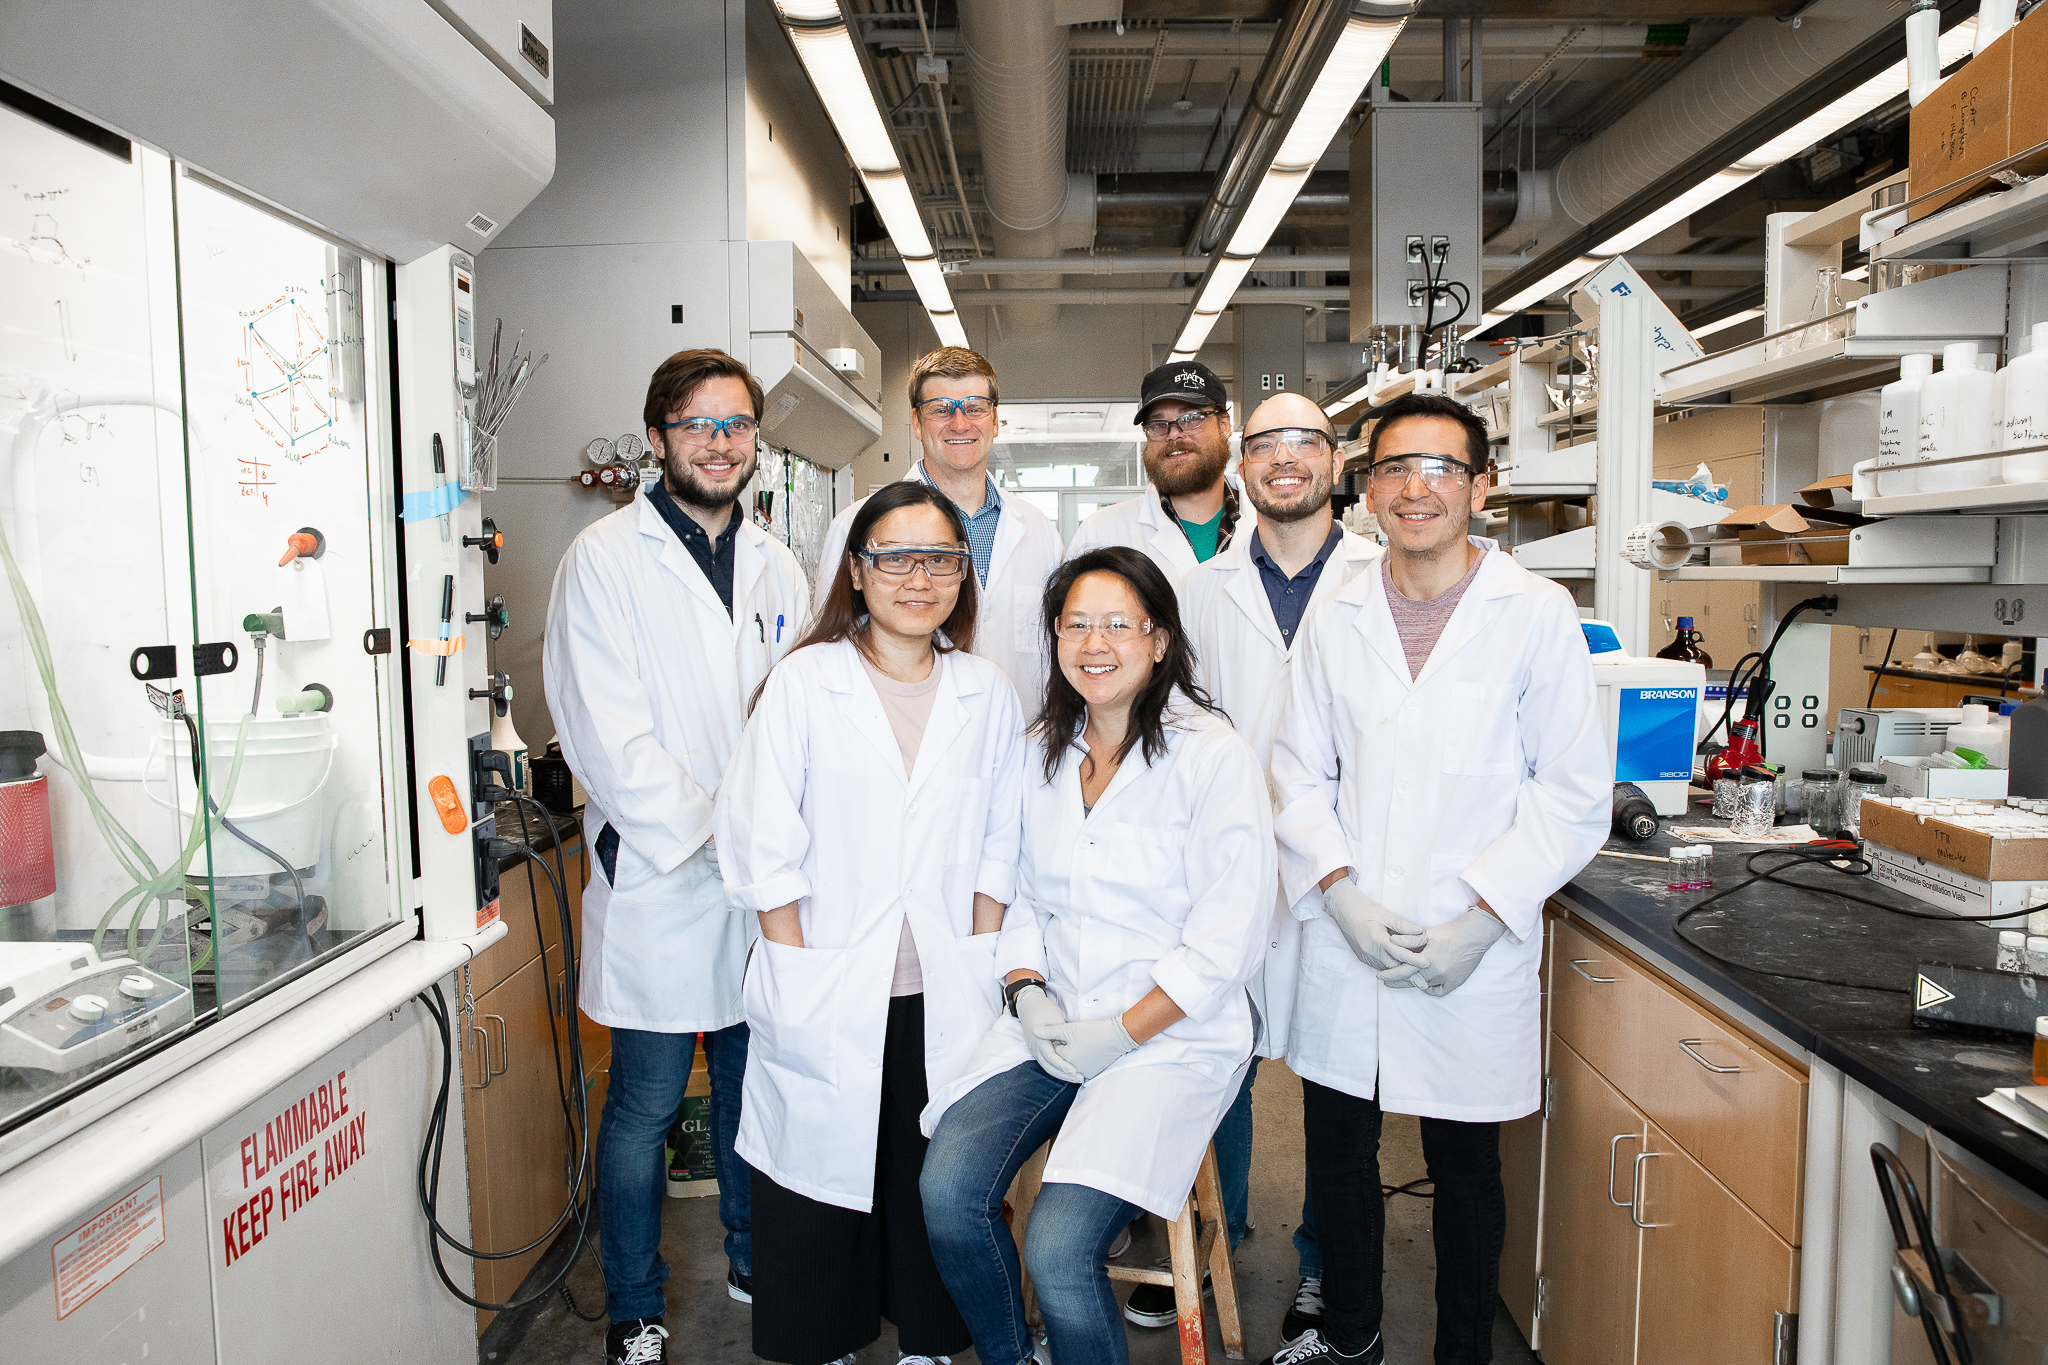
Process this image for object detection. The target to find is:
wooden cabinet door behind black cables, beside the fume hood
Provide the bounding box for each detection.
[467,958,567,1332]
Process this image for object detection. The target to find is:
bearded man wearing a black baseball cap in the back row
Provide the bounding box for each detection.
[1067,360,1237,581]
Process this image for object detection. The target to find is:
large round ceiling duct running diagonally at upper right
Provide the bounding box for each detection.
[1491,0,1896,254]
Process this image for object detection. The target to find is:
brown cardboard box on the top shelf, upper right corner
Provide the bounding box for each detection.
[1907,6,2048,223]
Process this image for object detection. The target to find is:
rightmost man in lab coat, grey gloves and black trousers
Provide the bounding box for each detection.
[1270,395,1614,1365]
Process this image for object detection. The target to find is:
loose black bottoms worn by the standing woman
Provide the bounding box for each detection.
[754,995,973,1365]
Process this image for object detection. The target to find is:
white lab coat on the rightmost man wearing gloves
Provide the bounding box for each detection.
[1272,538,1614,1124]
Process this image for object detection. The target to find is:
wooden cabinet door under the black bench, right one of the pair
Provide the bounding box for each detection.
[1630,1124,1798,1365]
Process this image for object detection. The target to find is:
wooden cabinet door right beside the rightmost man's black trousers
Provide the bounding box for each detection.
[1538,1038,1649,1365]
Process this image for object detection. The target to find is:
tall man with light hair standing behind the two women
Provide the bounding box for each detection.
[817,346,1059,703]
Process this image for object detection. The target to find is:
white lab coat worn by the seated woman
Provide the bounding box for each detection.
[924,708,1276,1218]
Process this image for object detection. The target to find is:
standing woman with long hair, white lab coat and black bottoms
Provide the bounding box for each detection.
[713,483,1024,1365]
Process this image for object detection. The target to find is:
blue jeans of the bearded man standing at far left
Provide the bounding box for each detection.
[598,1023,754,1322]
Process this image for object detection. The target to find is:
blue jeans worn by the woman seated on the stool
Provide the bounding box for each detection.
[918,1062,1139,1365]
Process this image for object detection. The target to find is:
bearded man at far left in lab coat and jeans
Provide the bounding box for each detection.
[541,350,811,1363]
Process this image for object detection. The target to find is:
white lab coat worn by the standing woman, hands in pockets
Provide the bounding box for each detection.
[715,641,1024,1212]
